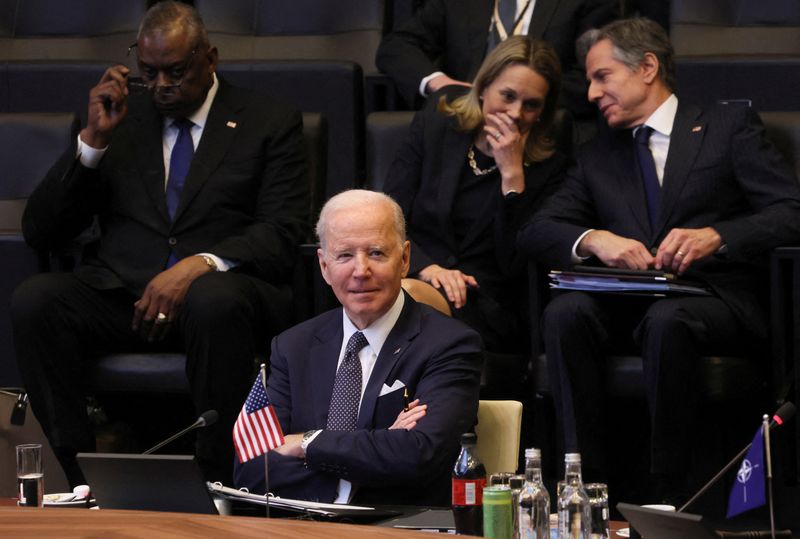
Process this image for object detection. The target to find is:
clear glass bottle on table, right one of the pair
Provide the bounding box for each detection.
[558,453,592,539]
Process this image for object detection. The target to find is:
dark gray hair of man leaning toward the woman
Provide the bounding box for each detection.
[576,17,677,93]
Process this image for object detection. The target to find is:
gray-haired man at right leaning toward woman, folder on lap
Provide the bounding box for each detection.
[520,19,800,499]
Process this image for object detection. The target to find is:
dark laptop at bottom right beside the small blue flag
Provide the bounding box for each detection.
[617,502,718,539]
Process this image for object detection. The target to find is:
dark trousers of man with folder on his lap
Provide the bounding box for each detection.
[543,292,753,475]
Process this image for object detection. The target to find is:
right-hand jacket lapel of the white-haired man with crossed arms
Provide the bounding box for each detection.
[356,292,420,429]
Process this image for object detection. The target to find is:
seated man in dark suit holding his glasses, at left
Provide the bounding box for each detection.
[11,2,308,486]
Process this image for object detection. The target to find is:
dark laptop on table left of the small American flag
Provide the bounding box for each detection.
[77,453,217,514]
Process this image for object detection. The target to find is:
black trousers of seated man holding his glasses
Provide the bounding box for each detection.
[11,272,292,486]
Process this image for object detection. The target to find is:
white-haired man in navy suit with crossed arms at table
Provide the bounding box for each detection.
[235,190,481,505]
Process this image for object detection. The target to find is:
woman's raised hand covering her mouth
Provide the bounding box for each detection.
[483,112,528,193]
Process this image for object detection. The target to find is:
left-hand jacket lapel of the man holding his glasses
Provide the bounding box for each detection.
[129,100,171,225]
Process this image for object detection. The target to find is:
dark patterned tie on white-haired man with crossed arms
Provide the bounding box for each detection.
[325,331,369,431]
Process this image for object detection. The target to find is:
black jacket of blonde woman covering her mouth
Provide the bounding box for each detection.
[385,90,566,308]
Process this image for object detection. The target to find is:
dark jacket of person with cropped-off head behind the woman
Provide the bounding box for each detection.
[375,0,618,116]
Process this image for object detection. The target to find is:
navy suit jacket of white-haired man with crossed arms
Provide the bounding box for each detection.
[234,294,482,505]
